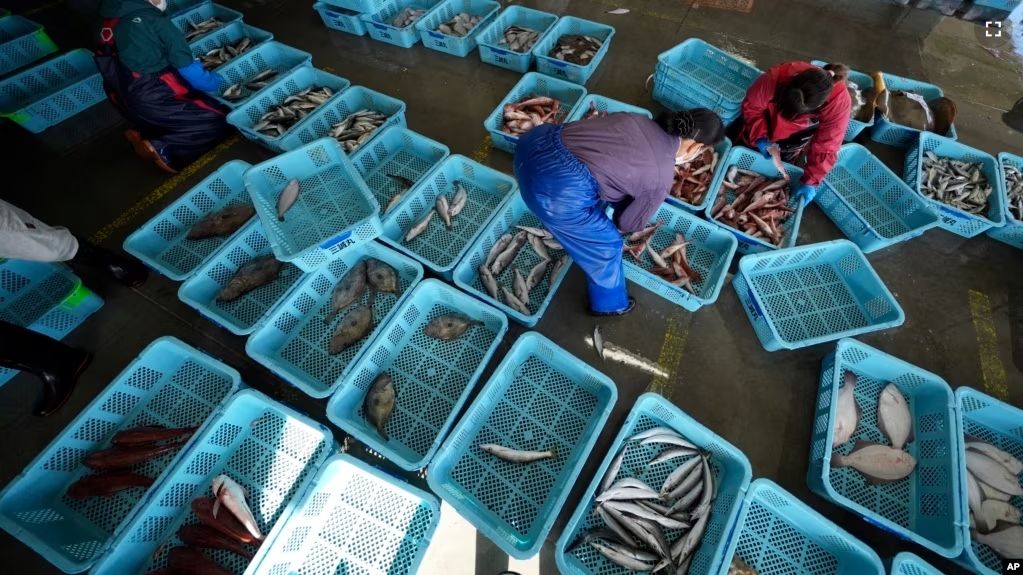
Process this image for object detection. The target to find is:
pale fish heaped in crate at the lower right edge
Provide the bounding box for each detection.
[963,435,1023,559]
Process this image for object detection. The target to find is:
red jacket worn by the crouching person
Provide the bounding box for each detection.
[740,61,852,186]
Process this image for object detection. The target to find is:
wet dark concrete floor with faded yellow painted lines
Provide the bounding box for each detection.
[0,0,1023,575]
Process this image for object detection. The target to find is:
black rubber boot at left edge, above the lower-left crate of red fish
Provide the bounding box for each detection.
[0,321,92,416]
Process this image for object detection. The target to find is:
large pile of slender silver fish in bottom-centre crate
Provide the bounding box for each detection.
[566,428,717,575]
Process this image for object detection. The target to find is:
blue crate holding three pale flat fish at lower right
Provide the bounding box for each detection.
[806,339,963,558]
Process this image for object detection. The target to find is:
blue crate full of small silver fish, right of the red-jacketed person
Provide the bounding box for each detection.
[902,132,1006,237]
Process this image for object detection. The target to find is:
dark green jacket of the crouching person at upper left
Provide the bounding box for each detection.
[99,0,194,74]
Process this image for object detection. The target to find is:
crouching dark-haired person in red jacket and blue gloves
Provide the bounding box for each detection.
[731,61,852,204]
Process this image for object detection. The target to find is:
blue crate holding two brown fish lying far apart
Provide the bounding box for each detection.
[326,279,508,471]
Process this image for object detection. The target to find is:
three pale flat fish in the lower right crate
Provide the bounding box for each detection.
[831,370,917,485]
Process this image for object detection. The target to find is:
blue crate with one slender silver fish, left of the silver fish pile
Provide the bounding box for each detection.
[427,331,618,559]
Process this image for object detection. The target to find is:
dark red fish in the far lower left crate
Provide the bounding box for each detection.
[68,426,198,499]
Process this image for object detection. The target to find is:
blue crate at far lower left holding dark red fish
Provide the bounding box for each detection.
[0,337,241,573]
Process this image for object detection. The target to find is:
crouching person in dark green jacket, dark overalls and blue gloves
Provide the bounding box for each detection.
[95,0,228,174]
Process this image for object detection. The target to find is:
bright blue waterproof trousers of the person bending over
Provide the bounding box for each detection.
[515,124,629,312]
